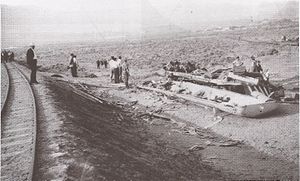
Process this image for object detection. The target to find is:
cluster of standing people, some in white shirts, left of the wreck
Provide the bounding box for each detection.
[109,56,129,88]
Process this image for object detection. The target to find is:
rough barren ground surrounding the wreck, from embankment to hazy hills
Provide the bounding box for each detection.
[9,19,299,180]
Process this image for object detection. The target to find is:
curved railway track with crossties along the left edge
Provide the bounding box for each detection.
[1,63,37,181]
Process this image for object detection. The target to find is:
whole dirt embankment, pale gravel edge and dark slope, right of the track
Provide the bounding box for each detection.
[15,63,298,180]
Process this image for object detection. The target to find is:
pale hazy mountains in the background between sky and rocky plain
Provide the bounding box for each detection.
[1,1,299,47]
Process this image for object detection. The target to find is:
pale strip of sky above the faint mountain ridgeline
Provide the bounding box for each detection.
[2,0,288,18]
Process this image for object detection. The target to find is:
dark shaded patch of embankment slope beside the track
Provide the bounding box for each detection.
[32,76,224,180]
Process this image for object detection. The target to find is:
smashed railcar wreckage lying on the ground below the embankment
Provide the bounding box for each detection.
[140,61,290,117]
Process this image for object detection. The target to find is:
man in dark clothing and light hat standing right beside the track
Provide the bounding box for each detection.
[26,45,38,84]
